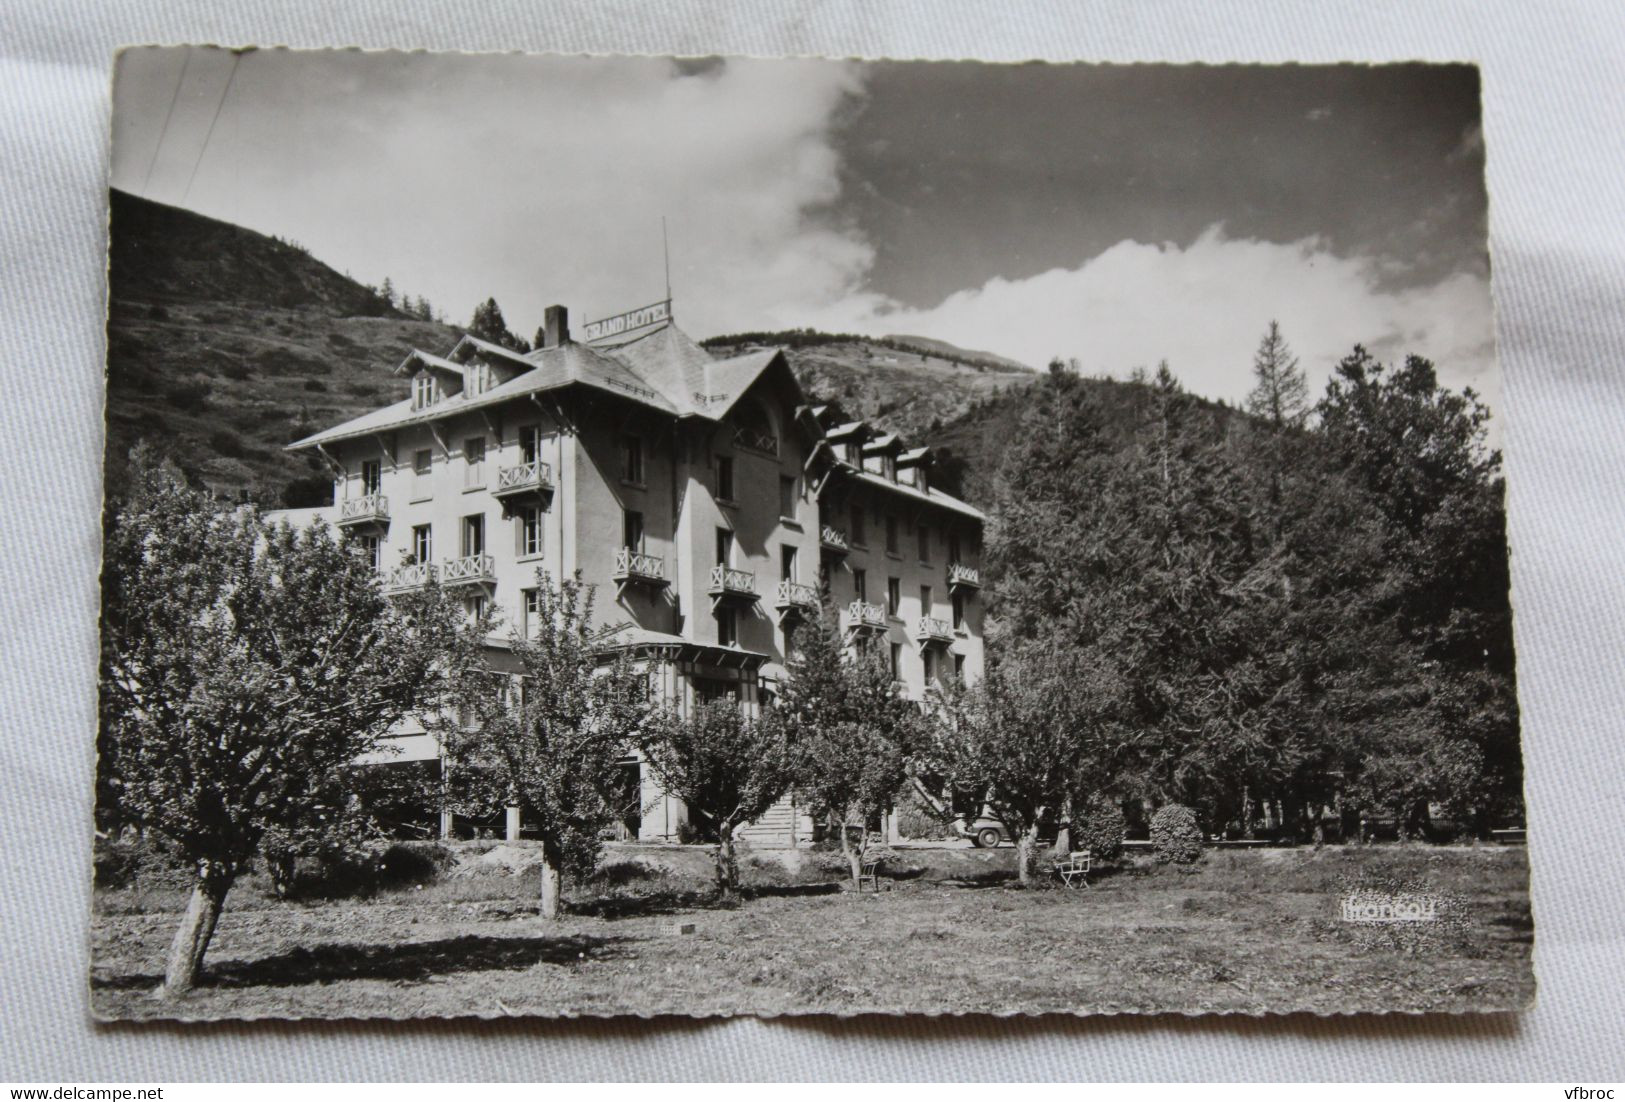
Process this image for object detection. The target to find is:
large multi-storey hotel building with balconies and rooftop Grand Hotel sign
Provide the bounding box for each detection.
[277,302,983,845]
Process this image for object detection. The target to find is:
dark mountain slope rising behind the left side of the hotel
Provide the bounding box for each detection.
[106,192,457,504]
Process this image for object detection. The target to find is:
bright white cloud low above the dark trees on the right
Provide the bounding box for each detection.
[816,226,1500,422]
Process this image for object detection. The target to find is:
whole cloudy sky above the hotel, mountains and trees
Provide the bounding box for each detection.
[112,49,1500,419]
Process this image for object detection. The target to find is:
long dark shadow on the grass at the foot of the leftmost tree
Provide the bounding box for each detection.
[91,935,624,991]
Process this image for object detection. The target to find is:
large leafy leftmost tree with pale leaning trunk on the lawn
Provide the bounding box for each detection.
[101,457,463,995]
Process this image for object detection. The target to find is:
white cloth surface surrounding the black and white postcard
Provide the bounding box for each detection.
[0,0,1625,1082]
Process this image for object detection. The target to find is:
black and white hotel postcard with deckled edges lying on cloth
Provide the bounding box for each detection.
[95,46,1544,1021]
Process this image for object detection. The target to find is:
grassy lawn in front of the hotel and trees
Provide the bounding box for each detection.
[91,847,1534,1019]
